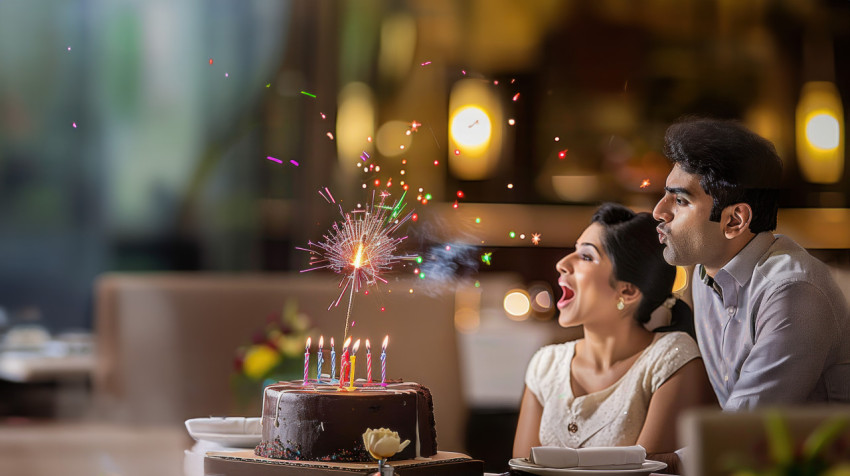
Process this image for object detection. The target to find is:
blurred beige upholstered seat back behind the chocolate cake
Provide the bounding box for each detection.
[95,273,466,451]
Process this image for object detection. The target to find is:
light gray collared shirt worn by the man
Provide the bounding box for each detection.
[692,232,850,410]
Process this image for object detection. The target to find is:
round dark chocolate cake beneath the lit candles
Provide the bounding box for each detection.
[255,380,437,462]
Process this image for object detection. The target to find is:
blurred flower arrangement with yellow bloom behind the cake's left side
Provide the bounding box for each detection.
[231,300,312,406]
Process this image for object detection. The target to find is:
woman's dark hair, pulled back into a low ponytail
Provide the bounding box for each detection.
[590,203,693,334]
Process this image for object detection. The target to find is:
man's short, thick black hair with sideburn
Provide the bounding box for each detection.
[664,118,782,233]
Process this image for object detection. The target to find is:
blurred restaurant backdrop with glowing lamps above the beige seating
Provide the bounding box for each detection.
[0,0,850,474]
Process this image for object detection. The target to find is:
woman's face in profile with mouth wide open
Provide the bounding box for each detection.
[555,223,620,327]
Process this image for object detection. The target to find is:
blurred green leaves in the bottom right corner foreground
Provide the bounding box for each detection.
[731,411,850,476]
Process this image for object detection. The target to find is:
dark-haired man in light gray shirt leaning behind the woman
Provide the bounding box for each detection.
[653,119,850,410]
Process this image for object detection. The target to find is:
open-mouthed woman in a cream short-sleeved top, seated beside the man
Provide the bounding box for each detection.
[513,204,714,460]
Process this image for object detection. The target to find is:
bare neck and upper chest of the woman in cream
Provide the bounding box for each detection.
[576,318,655,372]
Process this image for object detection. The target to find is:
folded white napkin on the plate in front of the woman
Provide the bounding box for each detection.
[529,445,646,469]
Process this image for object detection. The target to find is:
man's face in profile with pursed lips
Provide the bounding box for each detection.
[652,165,725,268]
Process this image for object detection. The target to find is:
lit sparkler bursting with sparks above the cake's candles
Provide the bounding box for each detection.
[296,188,416,339]
